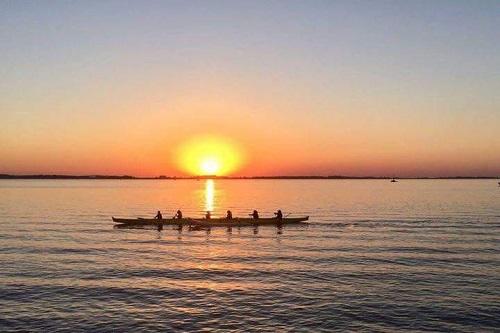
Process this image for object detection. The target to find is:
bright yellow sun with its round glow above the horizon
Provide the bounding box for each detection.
[177,136,243,176]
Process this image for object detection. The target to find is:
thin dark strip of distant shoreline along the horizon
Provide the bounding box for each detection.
[0,174,499,180]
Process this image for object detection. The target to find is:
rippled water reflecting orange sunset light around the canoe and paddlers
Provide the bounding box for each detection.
[0,180,500,332]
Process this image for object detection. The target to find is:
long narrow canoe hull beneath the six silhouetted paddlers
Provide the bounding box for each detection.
[113,216,309,227]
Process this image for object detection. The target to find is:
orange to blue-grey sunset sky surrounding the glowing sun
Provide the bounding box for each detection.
[0,0,500,177]
